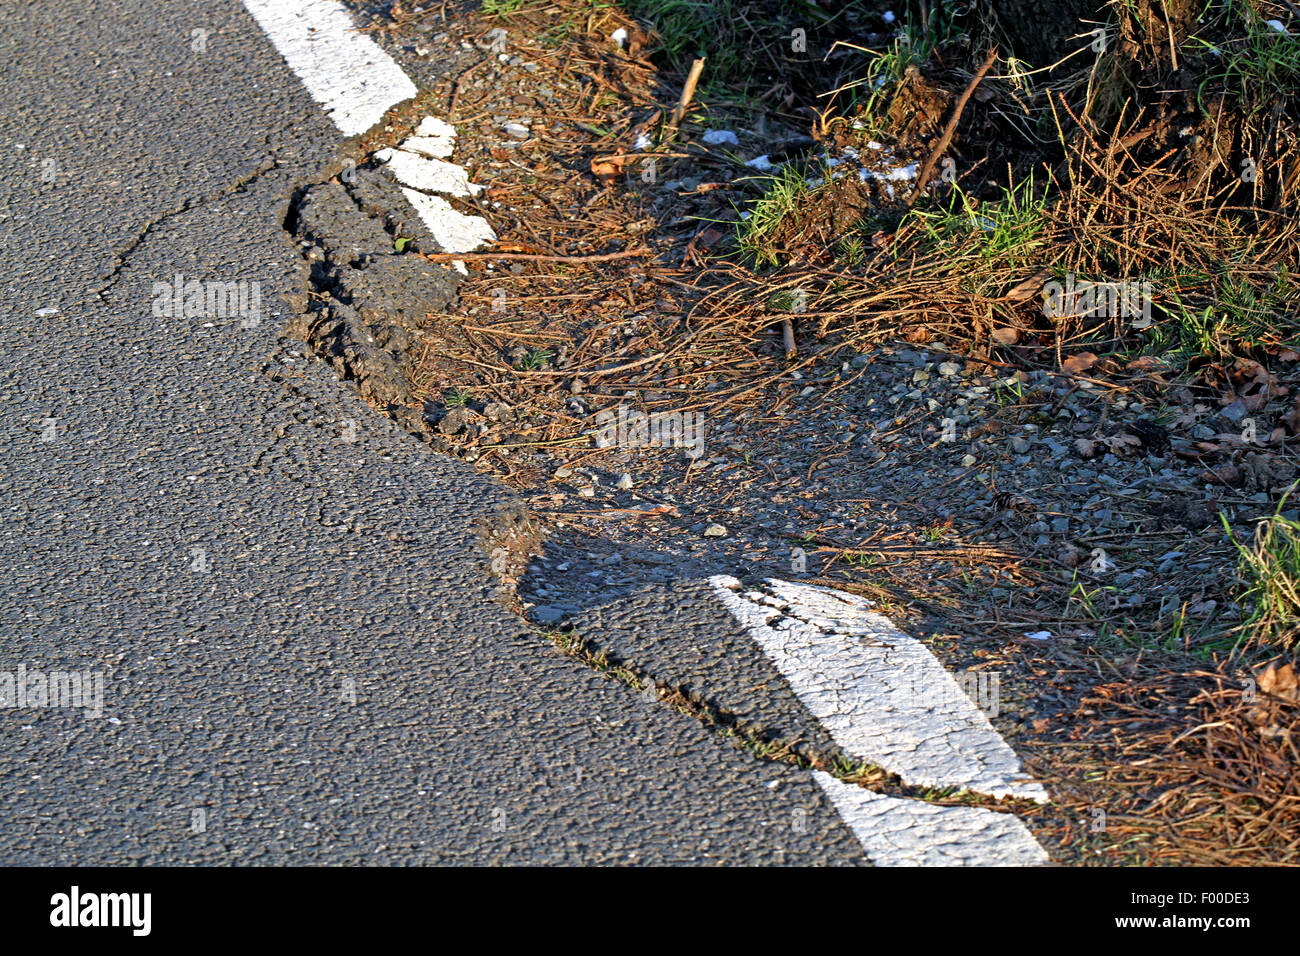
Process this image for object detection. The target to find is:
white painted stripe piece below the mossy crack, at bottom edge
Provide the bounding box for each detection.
[813,770,1050,866]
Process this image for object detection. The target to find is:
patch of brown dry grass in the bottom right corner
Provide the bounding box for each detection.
[1030,666,1300,866]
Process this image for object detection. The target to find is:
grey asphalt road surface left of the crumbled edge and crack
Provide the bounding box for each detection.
[0,0,863,864]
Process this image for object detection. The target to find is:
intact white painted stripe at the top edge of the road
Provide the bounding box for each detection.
[243,0,416,137]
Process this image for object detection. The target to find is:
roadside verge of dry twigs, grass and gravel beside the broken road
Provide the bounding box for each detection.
[356,0,1300,864]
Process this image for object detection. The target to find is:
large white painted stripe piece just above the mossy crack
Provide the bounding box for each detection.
[709,575,1048,803]
